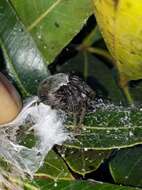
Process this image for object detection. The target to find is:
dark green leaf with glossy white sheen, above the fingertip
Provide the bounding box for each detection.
[0,0,48,95]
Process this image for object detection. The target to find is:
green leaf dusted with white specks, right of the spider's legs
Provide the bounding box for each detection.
[65,106,142,150]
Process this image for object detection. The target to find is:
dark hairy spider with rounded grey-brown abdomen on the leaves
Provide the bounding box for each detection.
[38,73,95,125]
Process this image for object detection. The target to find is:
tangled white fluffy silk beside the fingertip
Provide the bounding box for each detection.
[0,97,70,176]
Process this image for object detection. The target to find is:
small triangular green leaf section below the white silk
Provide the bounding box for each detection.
[35,150,73,180]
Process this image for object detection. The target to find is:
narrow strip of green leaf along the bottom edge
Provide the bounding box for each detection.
[25,179,140,190]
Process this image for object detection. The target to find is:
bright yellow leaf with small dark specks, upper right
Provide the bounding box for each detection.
[93,0,142,81]
